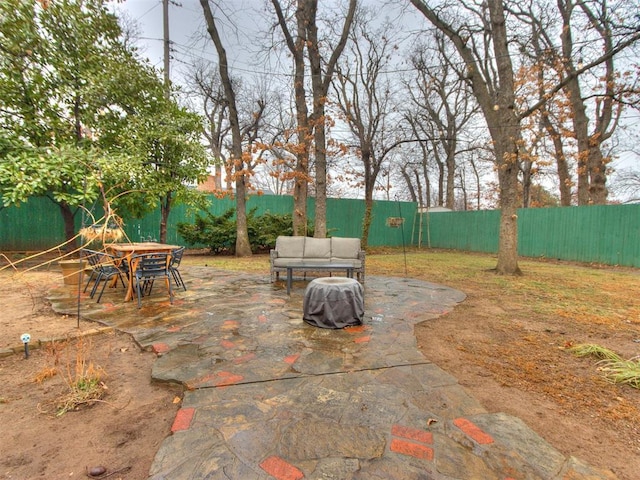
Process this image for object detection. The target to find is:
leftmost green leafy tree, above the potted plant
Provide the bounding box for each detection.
[0,0,130,246]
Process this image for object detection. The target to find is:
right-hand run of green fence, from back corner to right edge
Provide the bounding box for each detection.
[421,205,640,267]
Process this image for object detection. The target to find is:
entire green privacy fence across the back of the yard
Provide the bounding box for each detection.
[0,195,640,267]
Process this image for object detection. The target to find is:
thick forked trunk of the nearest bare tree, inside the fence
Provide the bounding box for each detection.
[411,0,522,275]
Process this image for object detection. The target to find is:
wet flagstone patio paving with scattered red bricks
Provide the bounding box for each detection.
[49,267,616,480]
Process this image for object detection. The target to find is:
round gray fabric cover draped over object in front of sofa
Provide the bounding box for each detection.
[303,277,364,328]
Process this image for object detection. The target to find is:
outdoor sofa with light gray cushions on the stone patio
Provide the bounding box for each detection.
[270,236,365,283]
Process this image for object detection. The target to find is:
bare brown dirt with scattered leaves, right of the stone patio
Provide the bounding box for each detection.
[416,292,640,480]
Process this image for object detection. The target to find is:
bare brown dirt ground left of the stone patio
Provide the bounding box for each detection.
[0,272,181,480]
